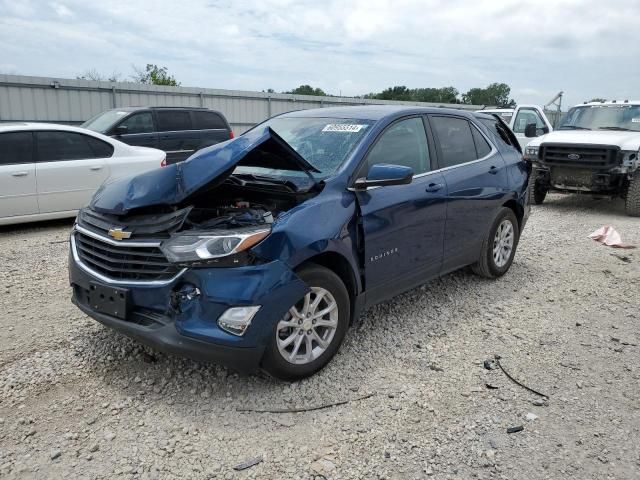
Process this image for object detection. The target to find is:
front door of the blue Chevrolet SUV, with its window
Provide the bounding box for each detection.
[357,117,446,304]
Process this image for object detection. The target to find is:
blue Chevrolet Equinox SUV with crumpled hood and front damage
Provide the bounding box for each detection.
[69,106,530,380]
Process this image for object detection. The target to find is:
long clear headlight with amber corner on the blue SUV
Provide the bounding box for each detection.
[160,227,271,263]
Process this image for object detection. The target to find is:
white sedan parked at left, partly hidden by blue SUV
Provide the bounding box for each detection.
[0,123,166,225]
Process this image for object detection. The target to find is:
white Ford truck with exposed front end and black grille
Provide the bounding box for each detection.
[516,100,640,217]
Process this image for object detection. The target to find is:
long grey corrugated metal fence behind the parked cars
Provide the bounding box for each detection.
[0,75,481,134]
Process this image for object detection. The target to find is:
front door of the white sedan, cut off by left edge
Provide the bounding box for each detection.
[0,132,38,218]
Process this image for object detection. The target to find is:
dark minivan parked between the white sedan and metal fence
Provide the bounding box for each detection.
[82,107,233,164]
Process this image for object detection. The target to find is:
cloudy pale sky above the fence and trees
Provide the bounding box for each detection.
[0,0,640,106]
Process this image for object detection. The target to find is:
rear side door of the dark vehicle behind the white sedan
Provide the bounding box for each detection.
[155,109,200,164]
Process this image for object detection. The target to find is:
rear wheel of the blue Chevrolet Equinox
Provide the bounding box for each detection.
[471,207,520,278]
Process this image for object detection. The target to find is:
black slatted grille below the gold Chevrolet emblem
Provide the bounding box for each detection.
[74,231,179,281]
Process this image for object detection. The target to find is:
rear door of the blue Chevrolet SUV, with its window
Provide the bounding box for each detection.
[429,115,508,272]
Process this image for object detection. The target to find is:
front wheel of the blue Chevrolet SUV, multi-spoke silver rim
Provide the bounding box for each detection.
[262,263,351,381]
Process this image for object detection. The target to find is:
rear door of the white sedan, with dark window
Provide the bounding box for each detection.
[36,130,113,213]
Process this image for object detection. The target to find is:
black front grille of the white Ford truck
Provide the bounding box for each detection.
[540,143,620,169]
